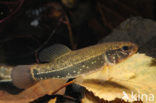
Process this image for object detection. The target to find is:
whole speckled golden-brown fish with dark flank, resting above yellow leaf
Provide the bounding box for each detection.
[11,42,138,88]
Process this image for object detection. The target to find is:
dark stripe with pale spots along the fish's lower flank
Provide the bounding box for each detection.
[32,55,105,80]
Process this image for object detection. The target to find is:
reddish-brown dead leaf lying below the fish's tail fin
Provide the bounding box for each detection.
[0,79,66,103]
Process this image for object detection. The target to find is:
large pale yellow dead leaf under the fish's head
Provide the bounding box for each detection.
[76,53,156,103]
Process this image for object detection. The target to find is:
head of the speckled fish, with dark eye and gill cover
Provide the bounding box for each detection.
[104,42,138,64]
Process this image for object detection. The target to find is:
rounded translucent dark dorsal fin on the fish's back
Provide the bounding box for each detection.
[39,44,71,62]
